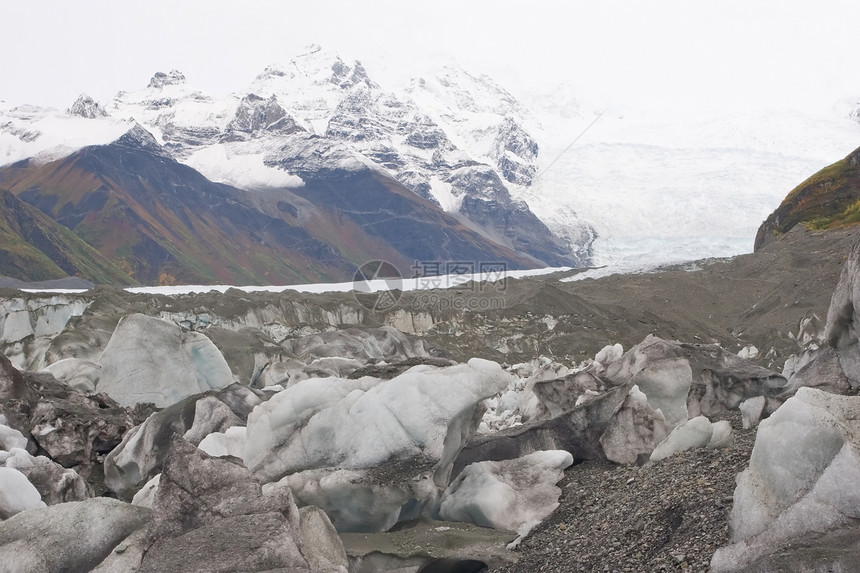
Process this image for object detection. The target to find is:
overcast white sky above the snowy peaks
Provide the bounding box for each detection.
[0,0,860,115]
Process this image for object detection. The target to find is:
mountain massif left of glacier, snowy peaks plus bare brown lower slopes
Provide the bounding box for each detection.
[0,47,593,284]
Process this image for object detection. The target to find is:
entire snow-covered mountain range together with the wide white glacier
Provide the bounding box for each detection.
[5,46,860,278]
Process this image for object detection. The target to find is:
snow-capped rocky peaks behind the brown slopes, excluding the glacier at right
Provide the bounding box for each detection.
[92,46,593,265]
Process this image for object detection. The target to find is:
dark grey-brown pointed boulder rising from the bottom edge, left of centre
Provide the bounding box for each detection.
[139,436,320,573]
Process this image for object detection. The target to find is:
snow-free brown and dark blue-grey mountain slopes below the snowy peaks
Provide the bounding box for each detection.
[0,125,535,284]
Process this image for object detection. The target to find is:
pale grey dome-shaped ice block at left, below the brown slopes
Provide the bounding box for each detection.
[97,314,233,408]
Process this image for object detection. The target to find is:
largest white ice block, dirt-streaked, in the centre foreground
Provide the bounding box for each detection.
[244,359,509,531]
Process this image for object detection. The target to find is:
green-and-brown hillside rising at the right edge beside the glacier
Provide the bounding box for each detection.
[755,142,860,249]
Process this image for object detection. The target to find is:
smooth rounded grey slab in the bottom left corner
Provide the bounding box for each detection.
[0,496,150,573]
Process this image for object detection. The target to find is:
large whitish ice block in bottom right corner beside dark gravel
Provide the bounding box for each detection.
[711,388,860,572]
